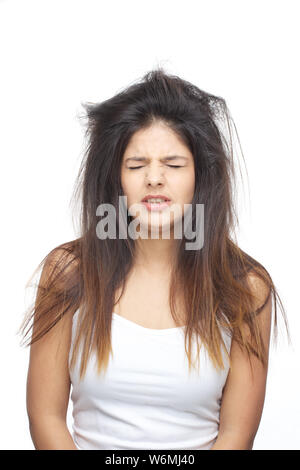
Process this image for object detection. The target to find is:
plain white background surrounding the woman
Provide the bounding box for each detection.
[0,0,300,449]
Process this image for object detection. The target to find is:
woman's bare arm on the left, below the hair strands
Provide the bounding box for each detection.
[27,252,77,450]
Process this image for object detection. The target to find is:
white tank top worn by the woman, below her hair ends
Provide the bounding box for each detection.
[69,311,231,450]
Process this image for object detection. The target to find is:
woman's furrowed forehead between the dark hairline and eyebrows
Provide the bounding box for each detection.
[124,123,192,158]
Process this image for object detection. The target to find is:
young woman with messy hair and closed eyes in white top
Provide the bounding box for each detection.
[18,69,285,450]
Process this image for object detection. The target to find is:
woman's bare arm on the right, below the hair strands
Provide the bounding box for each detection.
[211,278,272,450]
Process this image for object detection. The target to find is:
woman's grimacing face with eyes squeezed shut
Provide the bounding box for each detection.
[121,122,195,239]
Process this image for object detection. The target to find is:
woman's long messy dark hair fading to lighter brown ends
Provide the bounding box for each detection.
[21,68,287,378]
